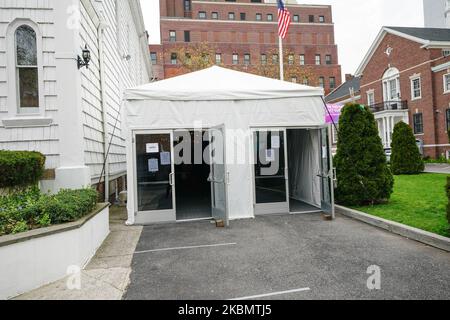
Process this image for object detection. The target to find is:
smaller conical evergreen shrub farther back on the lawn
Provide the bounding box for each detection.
[391,121,425,175]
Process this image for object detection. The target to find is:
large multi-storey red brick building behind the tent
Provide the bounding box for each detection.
[150,0,341,92]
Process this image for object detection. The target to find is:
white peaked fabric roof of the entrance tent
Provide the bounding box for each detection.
[125,66,324,101]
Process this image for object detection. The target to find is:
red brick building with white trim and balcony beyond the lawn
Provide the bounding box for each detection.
[327,27,450,158]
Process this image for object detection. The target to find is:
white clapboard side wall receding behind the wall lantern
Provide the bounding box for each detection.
[81,0,150,182]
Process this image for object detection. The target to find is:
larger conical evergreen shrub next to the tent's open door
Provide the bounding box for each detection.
[334,104,394,205]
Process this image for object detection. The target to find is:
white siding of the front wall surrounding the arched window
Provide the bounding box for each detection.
[0,0,59,168]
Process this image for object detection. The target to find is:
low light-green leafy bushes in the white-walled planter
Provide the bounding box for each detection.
[0,187,97,236]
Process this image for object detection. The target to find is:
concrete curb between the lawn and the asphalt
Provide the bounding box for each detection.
[336,205,450,252]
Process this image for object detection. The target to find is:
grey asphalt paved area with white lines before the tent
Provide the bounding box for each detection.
[124,214,450,300]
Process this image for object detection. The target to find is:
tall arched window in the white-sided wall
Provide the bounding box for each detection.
[14,25,39,112]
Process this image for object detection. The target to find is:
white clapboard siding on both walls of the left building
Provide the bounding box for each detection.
[0,0,150,183]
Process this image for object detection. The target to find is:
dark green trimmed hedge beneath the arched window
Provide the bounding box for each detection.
[0,150,45,189]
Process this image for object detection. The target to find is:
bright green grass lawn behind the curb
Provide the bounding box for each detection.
[354,174,450,237]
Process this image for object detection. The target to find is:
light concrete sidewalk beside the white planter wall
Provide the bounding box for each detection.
[16,206,142,300]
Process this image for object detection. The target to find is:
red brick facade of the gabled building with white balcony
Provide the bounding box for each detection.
[360,33,450,158]
